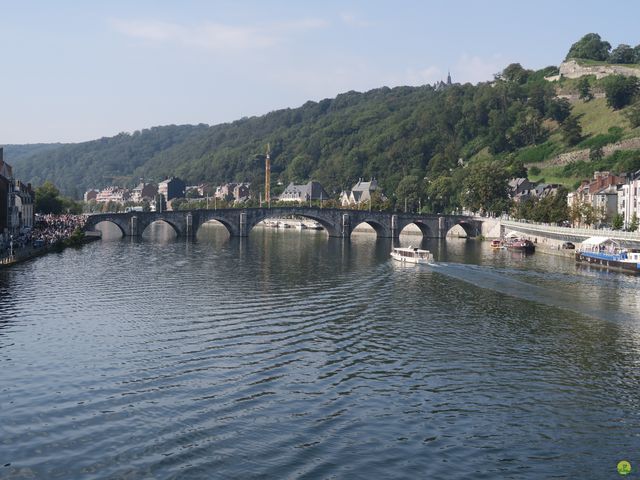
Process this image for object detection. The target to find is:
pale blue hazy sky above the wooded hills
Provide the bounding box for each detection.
[0,0,640,145]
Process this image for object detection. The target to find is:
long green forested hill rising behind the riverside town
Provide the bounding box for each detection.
[7,57,636,210]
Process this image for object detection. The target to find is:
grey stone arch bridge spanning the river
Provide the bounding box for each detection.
[85,207,483,238]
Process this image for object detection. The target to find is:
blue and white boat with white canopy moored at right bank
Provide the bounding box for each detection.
[576,237,640,273]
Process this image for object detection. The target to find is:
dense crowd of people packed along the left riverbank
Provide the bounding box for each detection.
[0,214,87,257]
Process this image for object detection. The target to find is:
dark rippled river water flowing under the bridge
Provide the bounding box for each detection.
[0,226,640,479]
